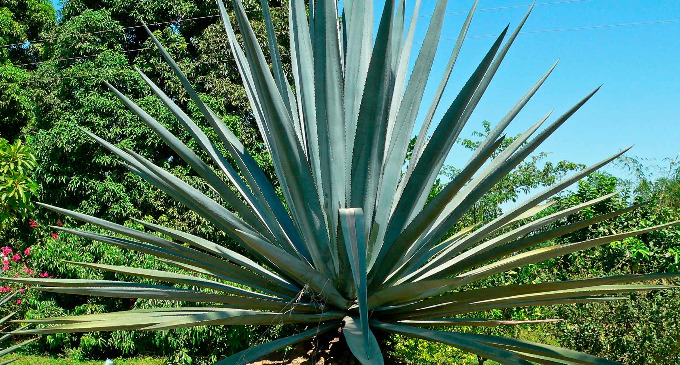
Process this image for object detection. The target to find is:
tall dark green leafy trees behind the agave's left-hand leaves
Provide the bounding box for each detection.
[0,1,289,364]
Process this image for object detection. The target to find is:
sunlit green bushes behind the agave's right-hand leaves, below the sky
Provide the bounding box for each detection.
[394,165,680,365]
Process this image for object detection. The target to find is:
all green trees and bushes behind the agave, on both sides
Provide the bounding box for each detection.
[0,0,680,364]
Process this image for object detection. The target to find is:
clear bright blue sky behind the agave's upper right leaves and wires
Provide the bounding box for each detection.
[376,0,680,174]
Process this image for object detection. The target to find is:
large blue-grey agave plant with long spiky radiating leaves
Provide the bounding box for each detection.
[10,0,680,364]
